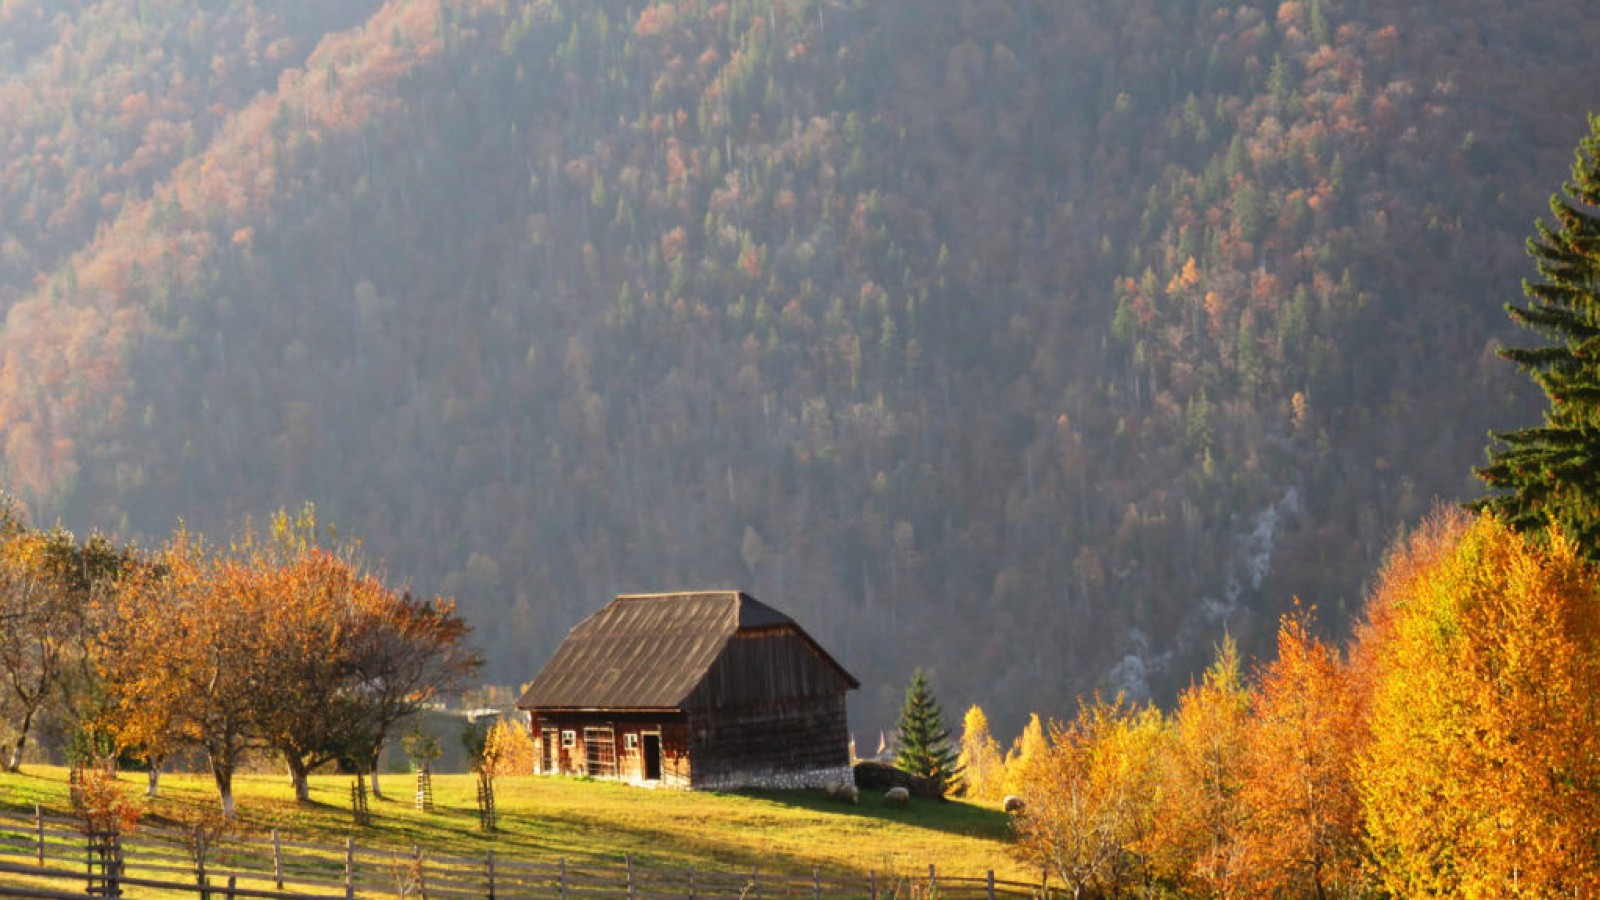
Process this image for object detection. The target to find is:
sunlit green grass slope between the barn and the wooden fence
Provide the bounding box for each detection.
[0,765,1037,881]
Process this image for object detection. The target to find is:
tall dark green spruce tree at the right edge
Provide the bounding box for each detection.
[1474,115,1600,560]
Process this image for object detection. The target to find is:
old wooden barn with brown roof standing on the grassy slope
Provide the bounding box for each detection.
[517,591,861,790]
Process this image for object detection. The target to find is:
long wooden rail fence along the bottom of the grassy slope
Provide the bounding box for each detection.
[0,807,1042,900]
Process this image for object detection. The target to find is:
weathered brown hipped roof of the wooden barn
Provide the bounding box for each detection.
[517,591,861,709]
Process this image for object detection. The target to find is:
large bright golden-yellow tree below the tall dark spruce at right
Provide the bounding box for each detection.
[1357,514,1600,897]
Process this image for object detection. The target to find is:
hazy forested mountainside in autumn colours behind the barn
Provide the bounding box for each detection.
[0,0,1600,732]
